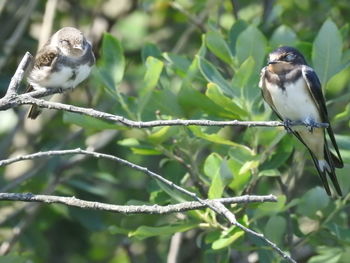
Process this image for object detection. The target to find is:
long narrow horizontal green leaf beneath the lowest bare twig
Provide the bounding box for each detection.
[129,224,198,240]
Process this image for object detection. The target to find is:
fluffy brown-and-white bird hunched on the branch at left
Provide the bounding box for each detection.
[27,27,95,119]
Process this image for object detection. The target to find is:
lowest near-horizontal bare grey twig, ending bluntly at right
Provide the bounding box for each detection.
[0,193,277,215]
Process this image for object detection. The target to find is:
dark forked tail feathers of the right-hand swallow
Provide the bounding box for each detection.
[310,145,343,196]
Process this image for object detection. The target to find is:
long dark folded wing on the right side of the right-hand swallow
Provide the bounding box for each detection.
[302,66,344,168]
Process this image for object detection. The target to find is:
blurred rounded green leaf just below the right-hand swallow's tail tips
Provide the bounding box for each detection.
[297,186,329,217]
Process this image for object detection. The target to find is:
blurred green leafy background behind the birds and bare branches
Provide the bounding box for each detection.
[0,0,350,263]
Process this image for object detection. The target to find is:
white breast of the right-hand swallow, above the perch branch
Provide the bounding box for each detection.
[266,77,321,126]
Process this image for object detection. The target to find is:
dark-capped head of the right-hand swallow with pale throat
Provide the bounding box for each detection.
[267,46,306,73]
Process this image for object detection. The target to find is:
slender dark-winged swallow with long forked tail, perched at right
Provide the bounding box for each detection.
[259,46,344,196]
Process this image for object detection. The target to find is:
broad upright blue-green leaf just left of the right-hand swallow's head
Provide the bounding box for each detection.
[236,25,266,71]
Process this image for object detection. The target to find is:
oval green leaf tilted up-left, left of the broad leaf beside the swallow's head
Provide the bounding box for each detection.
[205,31,232,65]
